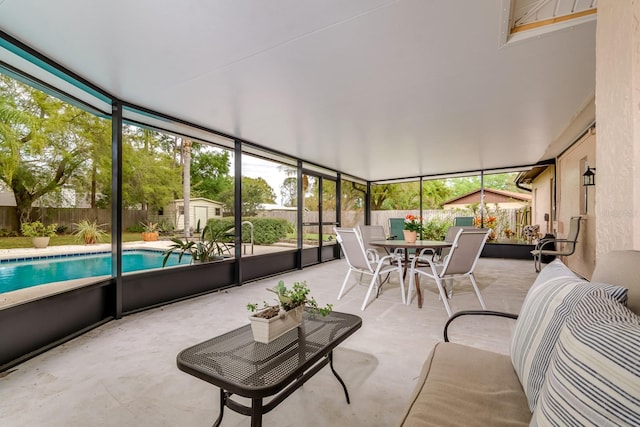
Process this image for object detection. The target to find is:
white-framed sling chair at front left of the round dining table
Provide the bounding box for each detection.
[334,227,406,310]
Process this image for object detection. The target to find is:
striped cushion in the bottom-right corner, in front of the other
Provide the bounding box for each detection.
[531,291,640,426]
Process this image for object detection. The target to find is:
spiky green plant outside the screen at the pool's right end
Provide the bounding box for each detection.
[162,224,234,267]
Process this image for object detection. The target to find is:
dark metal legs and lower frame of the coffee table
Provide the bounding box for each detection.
[213,351,351,427]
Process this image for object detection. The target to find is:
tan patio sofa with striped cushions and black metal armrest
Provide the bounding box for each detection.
[399,251,640,427]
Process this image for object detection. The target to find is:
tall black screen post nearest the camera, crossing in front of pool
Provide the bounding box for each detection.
[111,100,122,319]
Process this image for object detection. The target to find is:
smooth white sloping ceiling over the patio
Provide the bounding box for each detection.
[0,0,596,180]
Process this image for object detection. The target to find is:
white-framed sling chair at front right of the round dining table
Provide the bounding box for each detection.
[407,228,491,317]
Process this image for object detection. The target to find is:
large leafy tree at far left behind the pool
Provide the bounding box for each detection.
[0,75,90,224]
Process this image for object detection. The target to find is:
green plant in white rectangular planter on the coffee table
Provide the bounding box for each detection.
[247,280,333,344]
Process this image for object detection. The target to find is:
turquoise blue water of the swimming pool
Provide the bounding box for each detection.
[0,250,191,293]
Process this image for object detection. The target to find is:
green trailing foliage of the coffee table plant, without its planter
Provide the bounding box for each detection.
[247,280,333,319]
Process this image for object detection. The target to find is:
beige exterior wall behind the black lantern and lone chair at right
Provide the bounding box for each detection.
[554,131,598,277]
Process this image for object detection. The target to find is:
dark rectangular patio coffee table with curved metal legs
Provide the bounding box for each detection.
[177,311,362,427]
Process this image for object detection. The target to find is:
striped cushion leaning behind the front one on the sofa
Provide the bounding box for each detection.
[511,260,627,412]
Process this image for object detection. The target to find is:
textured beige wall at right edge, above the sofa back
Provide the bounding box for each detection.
[595,0,640,255]
